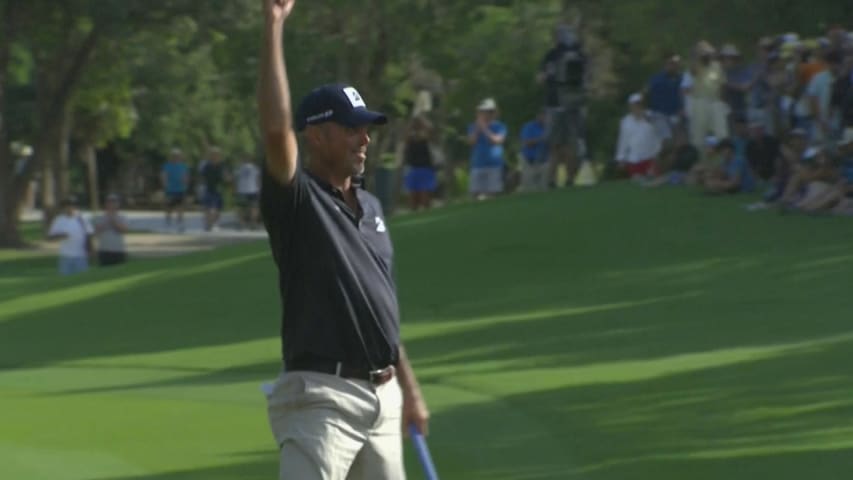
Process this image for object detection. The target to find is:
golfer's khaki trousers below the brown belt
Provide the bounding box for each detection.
[267,371,406,480]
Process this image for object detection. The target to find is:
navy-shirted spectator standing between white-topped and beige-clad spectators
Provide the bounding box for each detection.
[646,54,684,140]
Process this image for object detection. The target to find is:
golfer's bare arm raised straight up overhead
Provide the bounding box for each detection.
[258,0,298,184]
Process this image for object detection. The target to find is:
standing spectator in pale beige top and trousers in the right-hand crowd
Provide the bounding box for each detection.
[689,41,729,156]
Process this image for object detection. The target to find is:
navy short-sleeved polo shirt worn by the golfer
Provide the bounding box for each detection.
[261,168,400,369]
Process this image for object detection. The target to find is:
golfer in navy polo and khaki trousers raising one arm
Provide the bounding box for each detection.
[258,0,429,480]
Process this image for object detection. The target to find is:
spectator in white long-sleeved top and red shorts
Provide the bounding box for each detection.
[616,93,662,178]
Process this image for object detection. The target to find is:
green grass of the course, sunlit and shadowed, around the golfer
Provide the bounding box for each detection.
[0,184,853,480]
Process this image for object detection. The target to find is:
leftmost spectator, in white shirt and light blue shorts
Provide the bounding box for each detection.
[47,198,94,275]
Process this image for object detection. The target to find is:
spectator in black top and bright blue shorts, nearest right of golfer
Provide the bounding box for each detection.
[403,115,438,211]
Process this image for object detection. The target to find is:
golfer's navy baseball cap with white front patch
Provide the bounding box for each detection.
[296,83,388,132]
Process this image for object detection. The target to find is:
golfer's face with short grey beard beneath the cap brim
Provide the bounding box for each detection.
[312,122,370,176]
